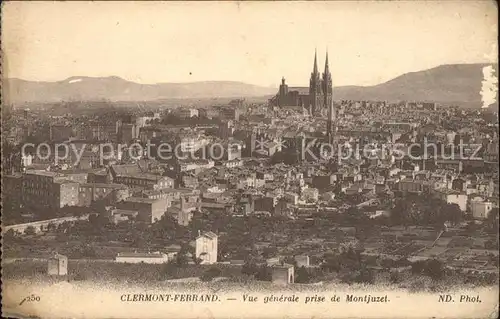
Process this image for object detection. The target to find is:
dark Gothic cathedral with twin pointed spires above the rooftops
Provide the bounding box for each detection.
[269,52,333,115]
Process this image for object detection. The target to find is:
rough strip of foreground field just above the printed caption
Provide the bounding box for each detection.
[2,260,498,292]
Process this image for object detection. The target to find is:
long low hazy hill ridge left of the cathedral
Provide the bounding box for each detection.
[2,76,275,104]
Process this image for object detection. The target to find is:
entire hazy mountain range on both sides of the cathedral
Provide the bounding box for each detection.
[2,64,498,107]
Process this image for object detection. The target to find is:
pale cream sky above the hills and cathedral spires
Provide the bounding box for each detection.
[2,0,498,86]
